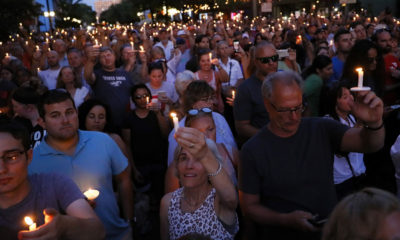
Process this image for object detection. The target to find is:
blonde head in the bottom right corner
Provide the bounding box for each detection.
[322,188,400,240]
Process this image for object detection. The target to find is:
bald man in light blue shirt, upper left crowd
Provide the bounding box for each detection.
[38,51,61,90]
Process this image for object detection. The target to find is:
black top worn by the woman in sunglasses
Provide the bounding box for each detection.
[123,111,167,167]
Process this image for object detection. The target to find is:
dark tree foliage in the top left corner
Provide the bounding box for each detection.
[0,0,42,41]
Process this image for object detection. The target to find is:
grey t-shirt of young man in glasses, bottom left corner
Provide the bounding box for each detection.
[0,174,84,240]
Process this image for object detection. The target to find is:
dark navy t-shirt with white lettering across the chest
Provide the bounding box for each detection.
[93,69,133,128]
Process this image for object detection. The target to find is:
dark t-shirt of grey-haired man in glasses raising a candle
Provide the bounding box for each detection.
[239,118,348,237]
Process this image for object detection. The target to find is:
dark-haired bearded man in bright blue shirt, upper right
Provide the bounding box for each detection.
[329,29,353,82]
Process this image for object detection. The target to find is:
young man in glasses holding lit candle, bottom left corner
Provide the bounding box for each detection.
[0,119,105,240]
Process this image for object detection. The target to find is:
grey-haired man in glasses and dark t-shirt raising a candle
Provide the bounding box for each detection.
[239,71,385,240]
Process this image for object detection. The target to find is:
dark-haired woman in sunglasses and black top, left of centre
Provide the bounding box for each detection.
[122,84,170,198]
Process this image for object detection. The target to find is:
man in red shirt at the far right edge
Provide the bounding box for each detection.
[372,29,400,105]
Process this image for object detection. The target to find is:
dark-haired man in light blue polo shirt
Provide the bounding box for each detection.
[29,90,133,239]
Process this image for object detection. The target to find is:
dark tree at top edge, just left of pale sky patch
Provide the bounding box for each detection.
[56,0,96,28]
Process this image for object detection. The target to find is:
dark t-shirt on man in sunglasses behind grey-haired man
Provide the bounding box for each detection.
[233,75,269,128]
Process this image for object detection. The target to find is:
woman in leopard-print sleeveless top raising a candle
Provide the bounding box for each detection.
[160,127,239,240]
